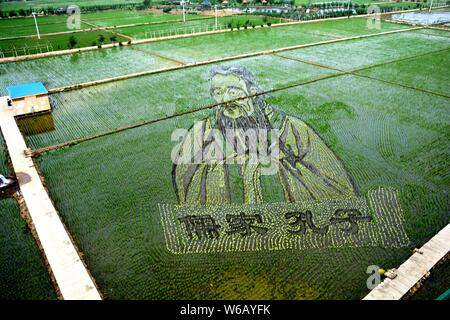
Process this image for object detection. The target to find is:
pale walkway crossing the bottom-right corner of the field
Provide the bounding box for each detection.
[363,224,450,300]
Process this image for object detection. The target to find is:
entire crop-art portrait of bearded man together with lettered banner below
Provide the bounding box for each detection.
[163,65,408,253]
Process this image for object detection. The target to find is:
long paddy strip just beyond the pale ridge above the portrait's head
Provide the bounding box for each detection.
[0,19,407,94]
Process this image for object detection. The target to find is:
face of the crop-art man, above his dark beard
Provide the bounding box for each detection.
[211,74,255,119]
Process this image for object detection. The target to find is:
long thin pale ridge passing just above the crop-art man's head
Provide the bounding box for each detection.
[48,27,423,94]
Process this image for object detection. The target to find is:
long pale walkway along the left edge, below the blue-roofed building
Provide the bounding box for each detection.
[0,97,101,300]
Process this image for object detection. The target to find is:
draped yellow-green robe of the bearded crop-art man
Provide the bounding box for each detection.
[172,108,357,205]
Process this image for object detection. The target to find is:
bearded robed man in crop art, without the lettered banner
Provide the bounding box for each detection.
[172,66,357,205]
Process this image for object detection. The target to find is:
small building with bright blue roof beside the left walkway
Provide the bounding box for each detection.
[7,82,51,115]
